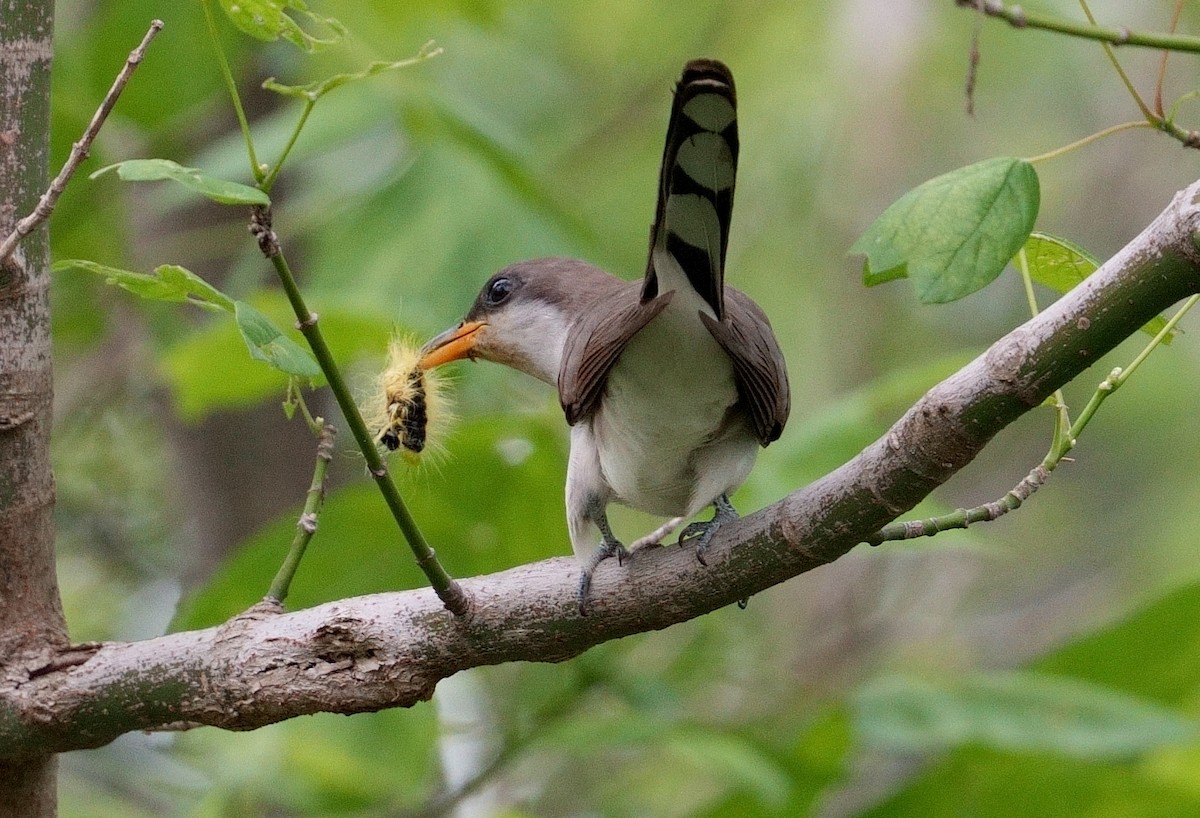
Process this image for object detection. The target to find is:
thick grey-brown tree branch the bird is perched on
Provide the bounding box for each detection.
[7,182,1200,758]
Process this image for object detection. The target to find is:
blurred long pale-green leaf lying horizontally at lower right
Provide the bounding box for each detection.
[853,673,1198,759]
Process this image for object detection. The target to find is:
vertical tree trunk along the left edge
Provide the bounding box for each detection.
[0,0,67,818]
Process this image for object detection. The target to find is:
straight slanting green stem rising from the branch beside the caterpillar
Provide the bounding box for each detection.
[251,207,470,615]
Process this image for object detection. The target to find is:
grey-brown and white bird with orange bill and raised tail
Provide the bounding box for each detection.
[420,59,791,615]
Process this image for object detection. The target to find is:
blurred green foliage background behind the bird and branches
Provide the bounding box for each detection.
[42,0,1200,818]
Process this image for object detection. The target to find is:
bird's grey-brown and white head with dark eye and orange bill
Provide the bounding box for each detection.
[420,258,622,384]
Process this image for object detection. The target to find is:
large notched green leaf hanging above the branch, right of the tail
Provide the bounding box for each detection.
[850,157,1040,303]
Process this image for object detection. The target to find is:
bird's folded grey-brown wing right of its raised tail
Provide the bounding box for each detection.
[700,287,792,446]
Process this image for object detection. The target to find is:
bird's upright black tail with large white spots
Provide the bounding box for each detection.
[642,60,738,320]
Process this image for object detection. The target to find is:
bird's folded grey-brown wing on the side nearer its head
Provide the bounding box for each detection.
[558,283,674,426]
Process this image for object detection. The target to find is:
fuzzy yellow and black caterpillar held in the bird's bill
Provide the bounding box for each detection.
[372,338,449,462]
